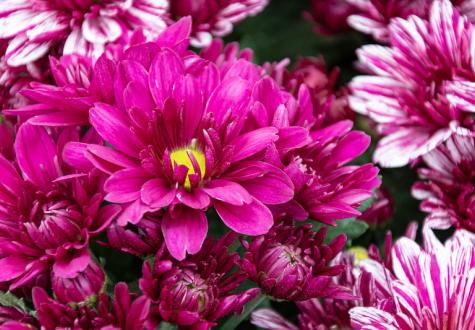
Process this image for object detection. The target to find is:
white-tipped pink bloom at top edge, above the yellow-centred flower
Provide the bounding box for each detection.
[170,0,269,47]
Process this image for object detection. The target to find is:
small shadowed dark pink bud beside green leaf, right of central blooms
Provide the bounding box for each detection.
[358,187,394,228]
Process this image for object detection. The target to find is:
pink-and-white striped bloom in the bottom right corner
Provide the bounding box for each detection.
[350,225,475,330]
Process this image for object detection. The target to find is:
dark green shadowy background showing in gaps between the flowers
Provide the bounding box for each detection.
[88,0,423,330]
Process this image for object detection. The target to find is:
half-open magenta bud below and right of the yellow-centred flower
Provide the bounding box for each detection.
[241,223,352,301]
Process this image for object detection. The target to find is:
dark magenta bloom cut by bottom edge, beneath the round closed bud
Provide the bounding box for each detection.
[33,283,150,330]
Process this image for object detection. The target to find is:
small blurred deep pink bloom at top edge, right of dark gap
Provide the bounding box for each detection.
[305,0,356,35]
